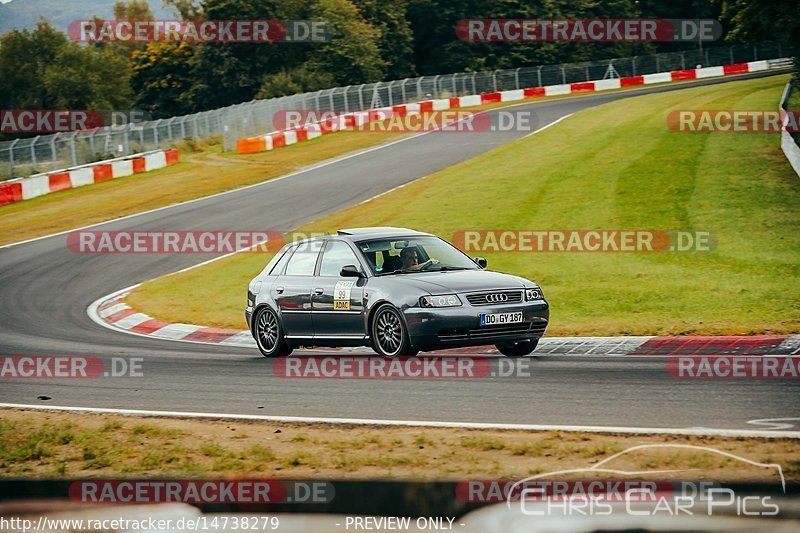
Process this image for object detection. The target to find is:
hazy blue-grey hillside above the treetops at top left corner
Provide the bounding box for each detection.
[0,0,177,34]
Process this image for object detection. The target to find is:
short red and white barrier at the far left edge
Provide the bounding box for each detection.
[0,150,179,209]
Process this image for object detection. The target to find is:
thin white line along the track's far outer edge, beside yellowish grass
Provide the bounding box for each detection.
[0,67,788,250]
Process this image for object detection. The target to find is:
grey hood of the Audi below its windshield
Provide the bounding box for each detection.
[388,270,535,294]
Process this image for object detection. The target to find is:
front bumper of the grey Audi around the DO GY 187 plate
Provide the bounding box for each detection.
[403,298,550,350]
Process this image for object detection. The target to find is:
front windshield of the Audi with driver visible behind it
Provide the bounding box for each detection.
[358,237,478,275]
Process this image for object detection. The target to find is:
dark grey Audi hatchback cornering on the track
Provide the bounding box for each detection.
[245,227,550,357]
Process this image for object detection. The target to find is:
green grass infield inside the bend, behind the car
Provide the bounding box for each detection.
[129,72,800,335]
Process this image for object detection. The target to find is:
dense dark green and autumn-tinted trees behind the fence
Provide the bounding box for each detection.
[0,0,800,132]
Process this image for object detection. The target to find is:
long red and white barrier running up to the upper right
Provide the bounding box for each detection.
[236,59,790,154]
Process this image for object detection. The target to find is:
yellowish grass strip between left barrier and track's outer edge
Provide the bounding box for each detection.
[0,76,756,245]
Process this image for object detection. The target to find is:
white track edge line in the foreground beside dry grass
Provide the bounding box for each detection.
[0,403,800,439]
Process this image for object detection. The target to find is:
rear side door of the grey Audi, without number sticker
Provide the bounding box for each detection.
[271,241,322,338]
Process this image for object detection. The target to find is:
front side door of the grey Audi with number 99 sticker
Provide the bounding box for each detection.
[311,239,367,339]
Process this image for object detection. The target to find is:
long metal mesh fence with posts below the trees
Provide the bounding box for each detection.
[0,43,787,179]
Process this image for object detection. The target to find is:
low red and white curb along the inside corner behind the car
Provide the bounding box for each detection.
[87,287,800,357]
